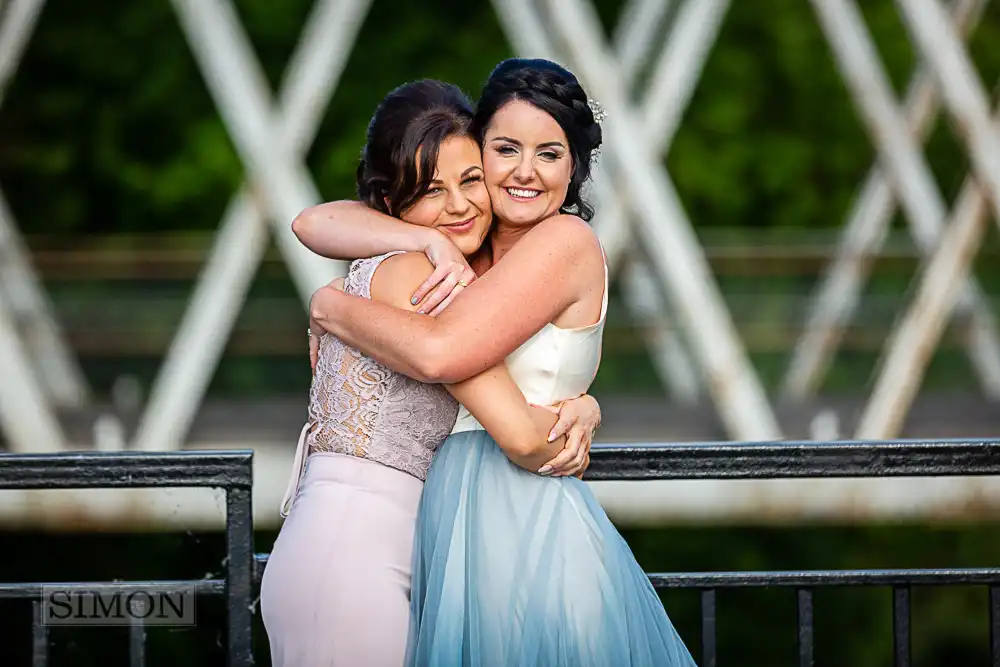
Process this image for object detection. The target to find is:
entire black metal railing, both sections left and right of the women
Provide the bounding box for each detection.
[0,440,1000,667]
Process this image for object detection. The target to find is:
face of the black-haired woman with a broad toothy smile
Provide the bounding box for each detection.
[483,100,573,225]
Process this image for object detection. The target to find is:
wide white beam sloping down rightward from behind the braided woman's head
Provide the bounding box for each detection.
[548,0,781,440]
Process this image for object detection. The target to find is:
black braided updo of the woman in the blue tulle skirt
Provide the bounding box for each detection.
[472,58,602,221]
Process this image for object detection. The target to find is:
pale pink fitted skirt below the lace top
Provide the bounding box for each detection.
[260,452,423,667]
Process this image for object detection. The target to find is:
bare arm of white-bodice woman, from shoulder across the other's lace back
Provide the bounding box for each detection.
[310,216,604,383]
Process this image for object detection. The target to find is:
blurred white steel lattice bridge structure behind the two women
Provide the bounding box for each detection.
[0,0,1000,526]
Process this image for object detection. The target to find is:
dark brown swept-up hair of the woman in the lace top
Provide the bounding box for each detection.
[356,79,474,218]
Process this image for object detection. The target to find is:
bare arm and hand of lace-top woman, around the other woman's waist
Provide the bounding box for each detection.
[371,253,600,475]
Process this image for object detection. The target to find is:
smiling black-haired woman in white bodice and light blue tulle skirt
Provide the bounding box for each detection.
[307,59,694,667]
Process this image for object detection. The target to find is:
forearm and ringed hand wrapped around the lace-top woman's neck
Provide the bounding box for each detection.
[292,201,476,315]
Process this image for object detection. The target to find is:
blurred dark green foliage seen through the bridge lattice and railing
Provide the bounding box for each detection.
[0,0,1000,667]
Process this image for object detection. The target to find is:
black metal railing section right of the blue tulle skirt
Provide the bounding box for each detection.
[586,439,1000,667]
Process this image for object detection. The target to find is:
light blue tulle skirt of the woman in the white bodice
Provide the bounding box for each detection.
[407,431,695,667]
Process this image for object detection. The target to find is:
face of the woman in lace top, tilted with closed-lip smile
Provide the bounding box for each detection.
[399,137,493,255]
